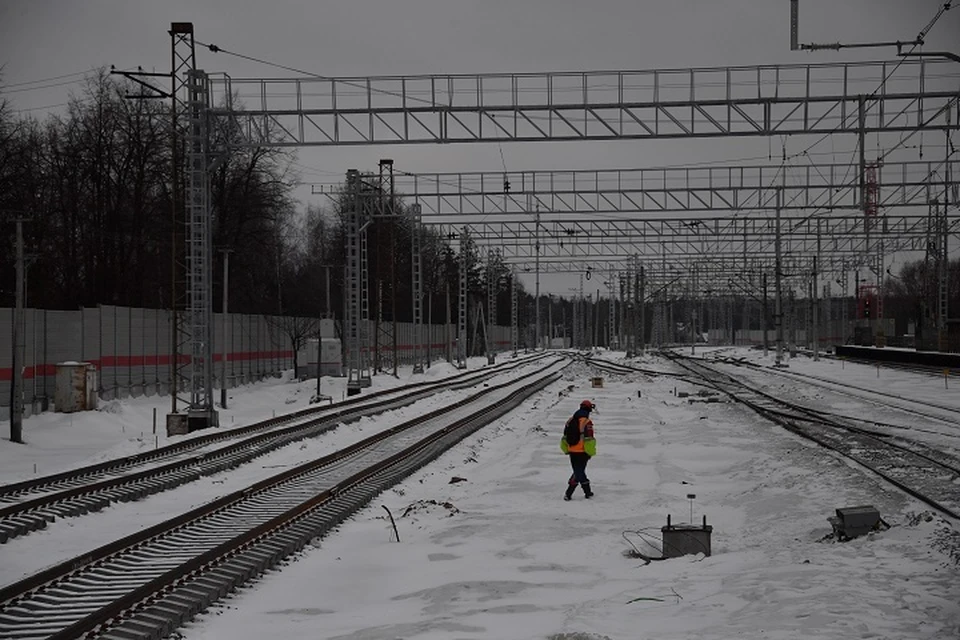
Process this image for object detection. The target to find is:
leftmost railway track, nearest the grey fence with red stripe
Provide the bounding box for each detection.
[0,356,543,544]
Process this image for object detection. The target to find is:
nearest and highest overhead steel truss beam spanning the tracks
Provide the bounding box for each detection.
[214,60,960,146]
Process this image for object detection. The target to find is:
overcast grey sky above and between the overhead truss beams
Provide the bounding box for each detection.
[0,0,960,292]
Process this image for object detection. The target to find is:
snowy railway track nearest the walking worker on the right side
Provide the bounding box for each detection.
[667,354,960,519]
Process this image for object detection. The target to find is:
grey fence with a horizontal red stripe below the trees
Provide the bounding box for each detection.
[0,305,510,420]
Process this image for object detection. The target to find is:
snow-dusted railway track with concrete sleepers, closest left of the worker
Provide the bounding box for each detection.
[0,360,567,640]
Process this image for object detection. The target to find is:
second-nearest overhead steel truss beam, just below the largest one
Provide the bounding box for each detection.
[384,160,960,223]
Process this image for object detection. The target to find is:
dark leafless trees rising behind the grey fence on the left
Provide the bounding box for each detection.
[0,70,528,340]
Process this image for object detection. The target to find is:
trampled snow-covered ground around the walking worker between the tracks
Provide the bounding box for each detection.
[0,349,960,640]
